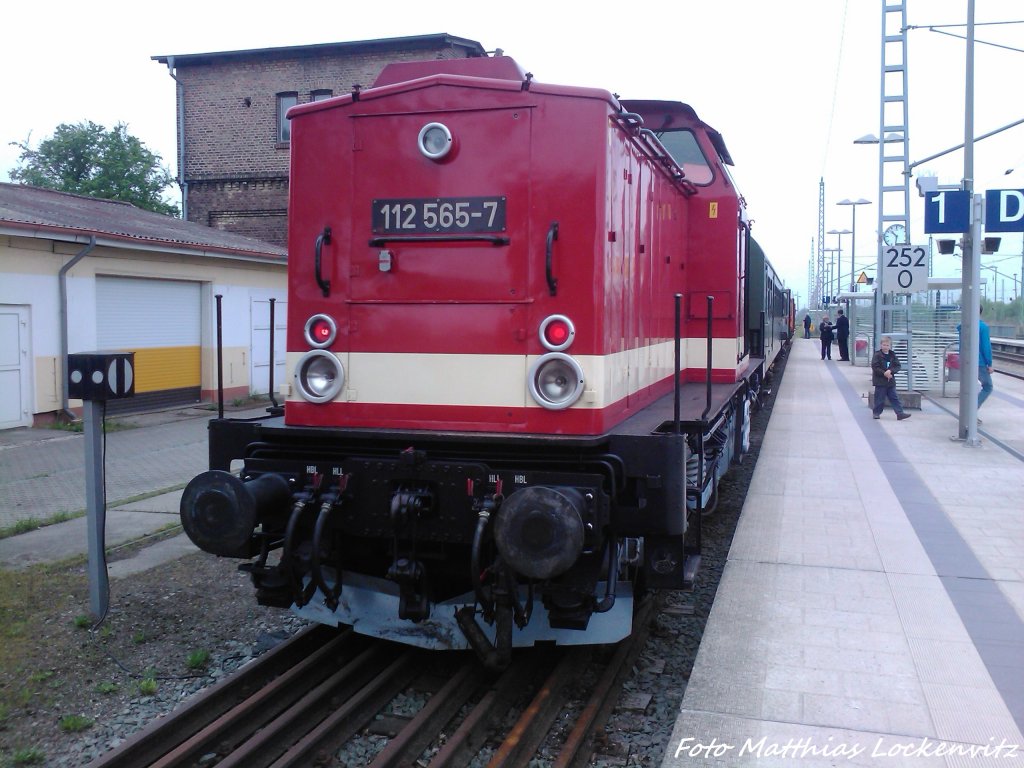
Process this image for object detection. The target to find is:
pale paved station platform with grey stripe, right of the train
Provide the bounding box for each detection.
[663,338,1024,768]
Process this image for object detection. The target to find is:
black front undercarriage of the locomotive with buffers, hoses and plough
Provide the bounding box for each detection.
[181,411,693,667]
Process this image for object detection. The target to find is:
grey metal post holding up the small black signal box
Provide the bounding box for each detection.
[82,400,110,622]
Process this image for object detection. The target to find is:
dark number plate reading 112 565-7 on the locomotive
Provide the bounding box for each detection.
[372,197,505,234]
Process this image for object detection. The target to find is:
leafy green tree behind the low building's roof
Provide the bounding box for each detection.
[10,121,180,216]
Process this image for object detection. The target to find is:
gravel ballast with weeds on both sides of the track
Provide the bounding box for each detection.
[0,360,784,768]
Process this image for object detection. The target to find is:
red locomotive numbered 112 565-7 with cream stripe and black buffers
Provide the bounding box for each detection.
[181,56,792,667]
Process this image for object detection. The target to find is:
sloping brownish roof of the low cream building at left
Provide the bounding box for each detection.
[0,183,287,263]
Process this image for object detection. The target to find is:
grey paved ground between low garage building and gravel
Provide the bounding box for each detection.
[0,408,265,578]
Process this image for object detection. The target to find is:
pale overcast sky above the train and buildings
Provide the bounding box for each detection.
[0,0,1024,307]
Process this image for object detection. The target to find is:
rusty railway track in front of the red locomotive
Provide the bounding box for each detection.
[91,599,654,768]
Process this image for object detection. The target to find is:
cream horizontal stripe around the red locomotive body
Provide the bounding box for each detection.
[288,339,741,409]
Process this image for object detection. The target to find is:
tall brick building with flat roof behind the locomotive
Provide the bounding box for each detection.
[153,34,485,247]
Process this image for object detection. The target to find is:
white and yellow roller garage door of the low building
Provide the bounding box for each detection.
[96,276,202,411]
